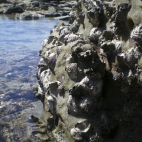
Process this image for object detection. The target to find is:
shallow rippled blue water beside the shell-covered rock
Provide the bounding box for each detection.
[0,15,59,142]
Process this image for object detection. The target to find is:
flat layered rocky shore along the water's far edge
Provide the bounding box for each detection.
[0,0,75,20]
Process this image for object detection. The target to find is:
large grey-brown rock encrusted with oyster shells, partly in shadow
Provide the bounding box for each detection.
[36,0,142,142]
